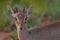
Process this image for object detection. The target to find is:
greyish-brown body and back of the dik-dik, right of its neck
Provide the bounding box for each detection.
[28,22,60,40]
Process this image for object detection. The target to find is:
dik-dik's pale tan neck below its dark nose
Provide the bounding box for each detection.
[17,25,27,40]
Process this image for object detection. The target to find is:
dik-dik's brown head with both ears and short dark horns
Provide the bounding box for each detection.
[8,6,32,30]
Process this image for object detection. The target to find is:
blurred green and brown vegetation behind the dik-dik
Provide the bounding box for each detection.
[0,0,60,39]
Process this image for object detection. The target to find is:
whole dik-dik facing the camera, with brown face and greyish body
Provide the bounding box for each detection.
[8,6,60,40]
